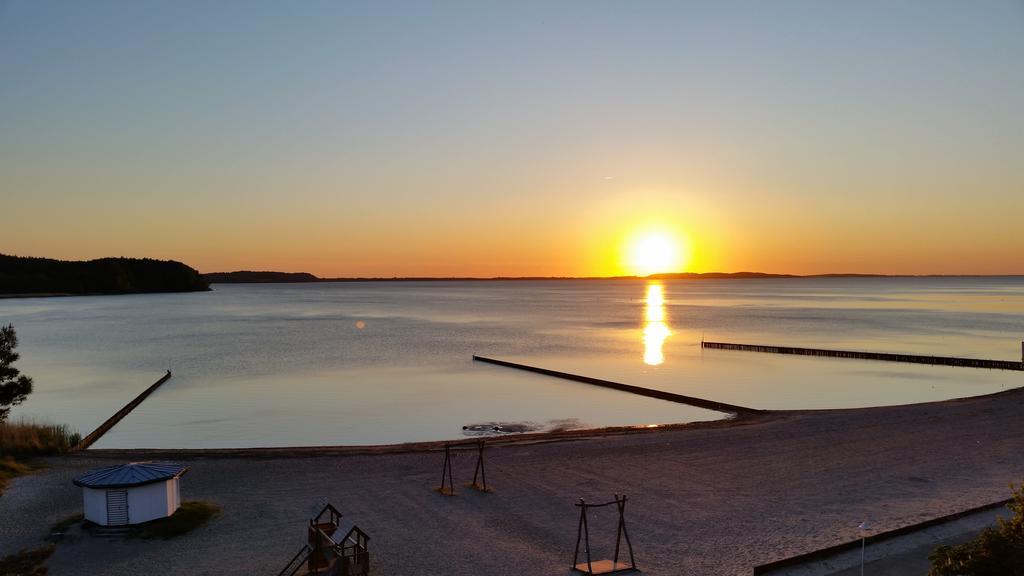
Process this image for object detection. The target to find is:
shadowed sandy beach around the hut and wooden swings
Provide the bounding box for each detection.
[6,389,1024,576]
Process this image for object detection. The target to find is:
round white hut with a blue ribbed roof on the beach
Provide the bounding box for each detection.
[75,462,188,526]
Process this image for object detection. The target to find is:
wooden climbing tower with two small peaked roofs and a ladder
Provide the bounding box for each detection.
[278,503,370,576]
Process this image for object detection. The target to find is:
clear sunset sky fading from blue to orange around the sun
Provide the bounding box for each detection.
[0,0,1024,276]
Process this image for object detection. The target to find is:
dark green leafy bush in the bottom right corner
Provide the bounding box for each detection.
[928,485,1024,576]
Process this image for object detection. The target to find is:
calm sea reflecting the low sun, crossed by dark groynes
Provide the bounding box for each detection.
[0,277,1024,448]
